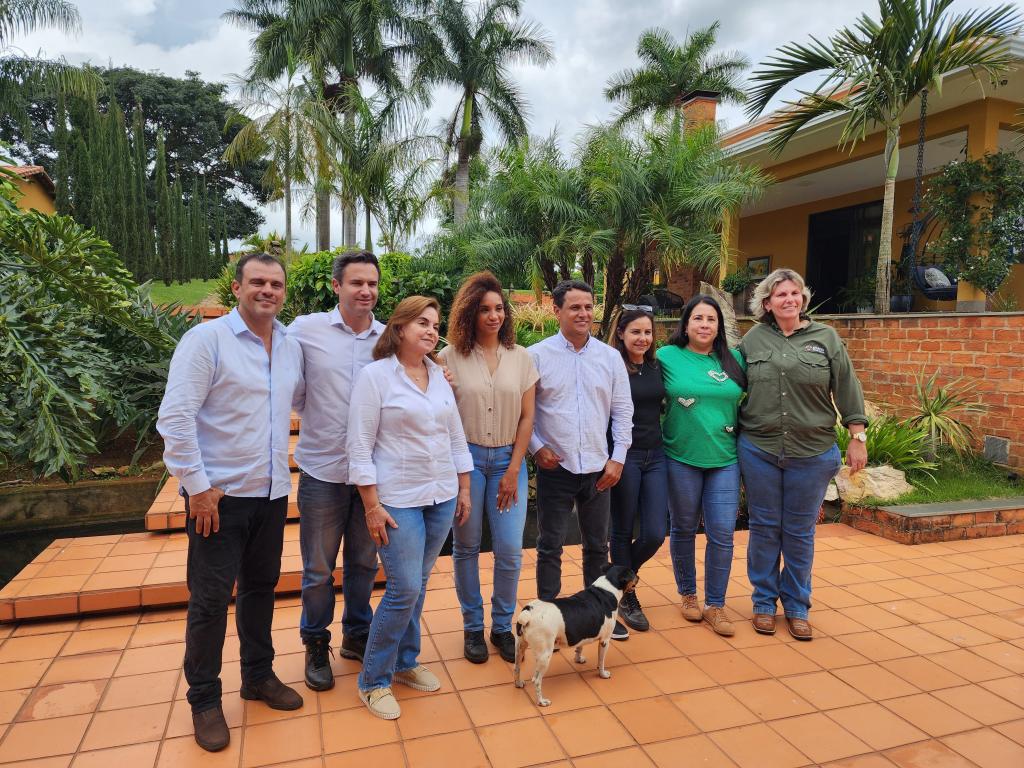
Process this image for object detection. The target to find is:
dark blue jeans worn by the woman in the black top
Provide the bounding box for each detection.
[608,445,669,573]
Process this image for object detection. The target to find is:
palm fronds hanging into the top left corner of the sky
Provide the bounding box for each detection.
[0,0,102,119]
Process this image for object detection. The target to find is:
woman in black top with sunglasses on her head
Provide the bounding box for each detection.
[608,308,669,640]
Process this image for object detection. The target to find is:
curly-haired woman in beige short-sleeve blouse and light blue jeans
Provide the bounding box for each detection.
[439,272,538,664]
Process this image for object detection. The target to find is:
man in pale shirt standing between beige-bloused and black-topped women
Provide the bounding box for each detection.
[529,281,633,600]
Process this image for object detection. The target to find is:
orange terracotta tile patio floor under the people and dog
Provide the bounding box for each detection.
[0,525,1024,768]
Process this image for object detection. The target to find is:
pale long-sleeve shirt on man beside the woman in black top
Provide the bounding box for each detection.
[529,333,633,474]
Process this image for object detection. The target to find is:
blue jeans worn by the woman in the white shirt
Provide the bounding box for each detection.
[358,499,456,690]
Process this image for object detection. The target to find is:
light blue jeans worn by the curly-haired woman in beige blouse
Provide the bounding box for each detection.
[452,442,528,632]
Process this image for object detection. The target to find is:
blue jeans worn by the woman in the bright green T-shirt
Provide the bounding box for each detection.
[669,459,739,607]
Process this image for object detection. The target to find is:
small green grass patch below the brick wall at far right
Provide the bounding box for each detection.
[863,456,1024,506]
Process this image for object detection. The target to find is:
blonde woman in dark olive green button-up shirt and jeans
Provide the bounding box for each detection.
[739,269,867,640]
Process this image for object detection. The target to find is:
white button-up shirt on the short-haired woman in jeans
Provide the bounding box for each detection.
[348,355,473,507]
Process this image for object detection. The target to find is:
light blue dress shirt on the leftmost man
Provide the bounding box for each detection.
[157,309,304,499]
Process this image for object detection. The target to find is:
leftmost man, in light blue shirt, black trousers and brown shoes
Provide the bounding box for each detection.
[157,253,303,752]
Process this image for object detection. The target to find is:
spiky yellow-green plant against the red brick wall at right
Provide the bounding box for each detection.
[909,371,988,458]
